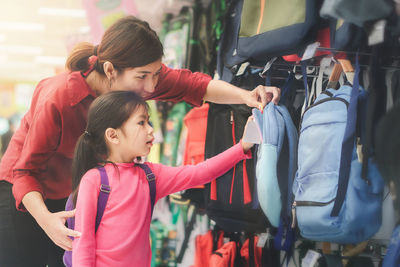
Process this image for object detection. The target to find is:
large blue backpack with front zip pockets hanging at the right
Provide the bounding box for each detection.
[293,57,383,243]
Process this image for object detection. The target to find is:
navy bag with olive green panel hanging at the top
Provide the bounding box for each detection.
[217,0,319,82]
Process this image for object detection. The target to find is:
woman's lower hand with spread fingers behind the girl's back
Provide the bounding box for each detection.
[38,210,81,250]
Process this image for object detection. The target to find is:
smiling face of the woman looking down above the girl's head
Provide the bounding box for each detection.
[111,59,162,99]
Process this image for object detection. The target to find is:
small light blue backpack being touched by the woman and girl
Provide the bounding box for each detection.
[253,103,298,227]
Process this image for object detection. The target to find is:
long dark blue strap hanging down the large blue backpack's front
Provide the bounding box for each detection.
[331,54,360,217]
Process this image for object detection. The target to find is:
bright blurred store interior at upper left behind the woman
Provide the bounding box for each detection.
[0,0,192,155]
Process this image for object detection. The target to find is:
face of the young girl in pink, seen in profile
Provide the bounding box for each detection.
[117,107,154,162]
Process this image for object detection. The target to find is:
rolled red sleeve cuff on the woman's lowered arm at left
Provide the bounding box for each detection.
[12,176,45,211]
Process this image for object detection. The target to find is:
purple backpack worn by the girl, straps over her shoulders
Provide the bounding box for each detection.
[63,164,156,267]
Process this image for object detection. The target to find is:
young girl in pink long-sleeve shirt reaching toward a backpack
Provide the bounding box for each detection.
[72,91,253,267]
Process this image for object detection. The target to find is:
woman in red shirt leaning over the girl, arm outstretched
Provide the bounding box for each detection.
[0,16,279,267]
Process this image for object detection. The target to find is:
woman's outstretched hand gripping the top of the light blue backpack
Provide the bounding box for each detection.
[244,85,281,111]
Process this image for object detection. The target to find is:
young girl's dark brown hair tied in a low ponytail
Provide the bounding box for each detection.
[72,91,148,203]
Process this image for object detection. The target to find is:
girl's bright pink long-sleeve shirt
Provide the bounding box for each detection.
[72,143,251,267]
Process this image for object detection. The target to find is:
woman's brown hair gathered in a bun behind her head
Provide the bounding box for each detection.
[65,42,96,71]
